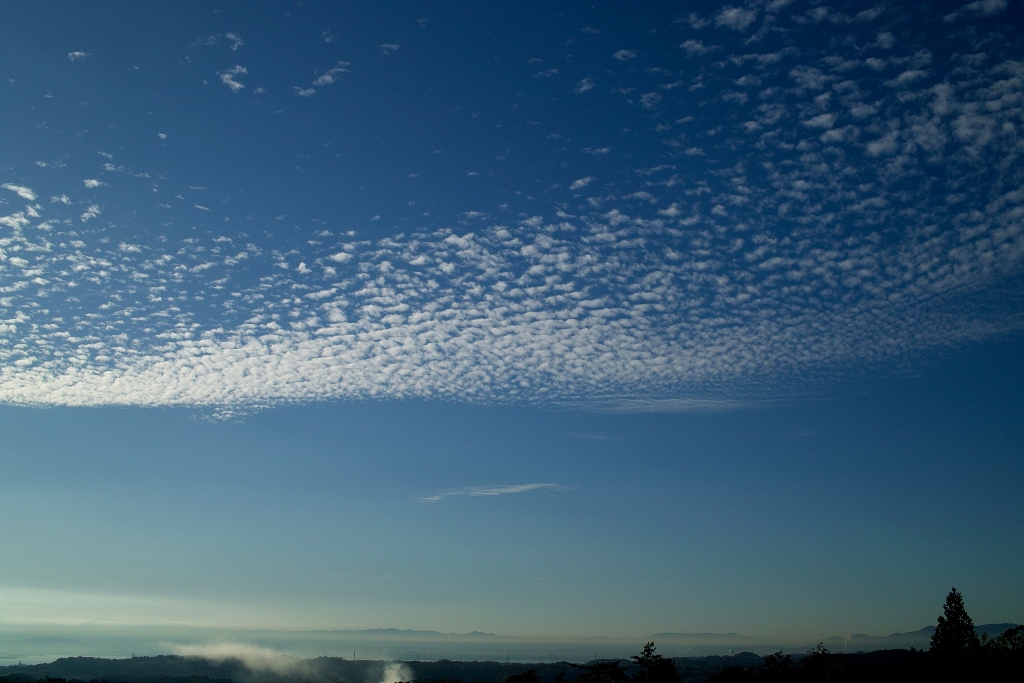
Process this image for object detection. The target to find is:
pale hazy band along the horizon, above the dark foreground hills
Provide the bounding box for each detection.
[0,623,1005,670]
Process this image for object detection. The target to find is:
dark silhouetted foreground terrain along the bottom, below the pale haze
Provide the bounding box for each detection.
[0,647,1024,683]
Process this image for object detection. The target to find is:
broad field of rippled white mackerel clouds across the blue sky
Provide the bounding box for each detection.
[0,2,1024,413]
